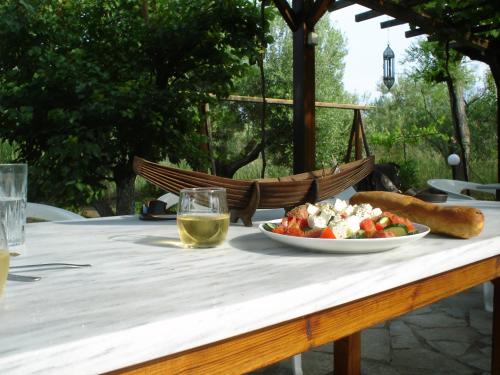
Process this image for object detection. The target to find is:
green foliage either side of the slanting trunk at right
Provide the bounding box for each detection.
[365,61,497,189]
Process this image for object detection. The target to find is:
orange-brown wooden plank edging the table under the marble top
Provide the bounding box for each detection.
[105,255,500,375]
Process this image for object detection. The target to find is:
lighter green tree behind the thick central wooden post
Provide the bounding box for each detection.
[212,17,352,176]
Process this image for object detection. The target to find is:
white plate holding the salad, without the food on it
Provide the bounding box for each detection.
[259,219,430,253]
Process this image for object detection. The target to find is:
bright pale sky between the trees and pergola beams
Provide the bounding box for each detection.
[328,4,486,102]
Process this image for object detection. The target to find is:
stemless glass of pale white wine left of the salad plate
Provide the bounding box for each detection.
[177,187,229,247]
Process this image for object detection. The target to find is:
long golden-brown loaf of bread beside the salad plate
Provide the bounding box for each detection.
[350,191,484,238]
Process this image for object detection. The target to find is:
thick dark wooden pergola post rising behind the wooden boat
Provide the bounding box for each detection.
[292,0,316,173]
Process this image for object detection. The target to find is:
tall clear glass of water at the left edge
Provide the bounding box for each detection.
[0,164,28,252]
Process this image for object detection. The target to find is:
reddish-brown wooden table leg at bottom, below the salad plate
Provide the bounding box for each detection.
[333,332,361,375]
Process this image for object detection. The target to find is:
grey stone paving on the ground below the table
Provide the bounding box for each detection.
[251,286,492,375]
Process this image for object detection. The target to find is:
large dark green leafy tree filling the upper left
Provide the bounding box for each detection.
[0,0,260,214]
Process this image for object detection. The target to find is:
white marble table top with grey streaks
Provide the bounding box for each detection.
[0,201,500,375]
